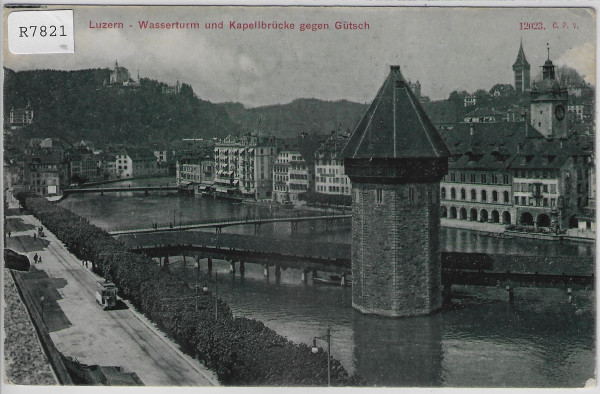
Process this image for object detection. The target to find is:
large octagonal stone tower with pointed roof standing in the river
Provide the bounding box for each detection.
[341,66,450,316]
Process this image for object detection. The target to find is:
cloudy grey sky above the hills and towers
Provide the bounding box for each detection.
[4,6,596,107]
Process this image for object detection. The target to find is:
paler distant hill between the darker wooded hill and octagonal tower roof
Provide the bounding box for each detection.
[220,99,367,137]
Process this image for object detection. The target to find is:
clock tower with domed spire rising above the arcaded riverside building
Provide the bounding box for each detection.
[529,48,569,138]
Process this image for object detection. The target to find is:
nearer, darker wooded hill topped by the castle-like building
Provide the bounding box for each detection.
[4,69,238,143]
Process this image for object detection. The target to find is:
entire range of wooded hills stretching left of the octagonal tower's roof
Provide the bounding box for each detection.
[4,69,366,145]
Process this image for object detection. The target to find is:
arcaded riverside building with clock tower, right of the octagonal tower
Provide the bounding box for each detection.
[440,50,595,231]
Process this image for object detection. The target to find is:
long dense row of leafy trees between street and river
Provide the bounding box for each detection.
[17,193,364,386]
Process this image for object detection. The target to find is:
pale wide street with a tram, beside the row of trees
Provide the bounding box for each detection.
[6,215,218,386]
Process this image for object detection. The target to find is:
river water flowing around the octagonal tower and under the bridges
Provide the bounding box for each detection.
[60,181,595,387]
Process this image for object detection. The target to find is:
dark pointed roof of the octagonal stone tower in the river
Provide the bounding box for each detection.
[341,66,450,159]
